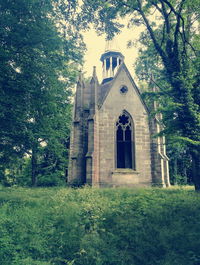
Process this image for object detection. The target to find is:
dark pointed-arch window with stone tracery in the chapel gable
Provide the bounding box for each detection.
[116,111,135,169]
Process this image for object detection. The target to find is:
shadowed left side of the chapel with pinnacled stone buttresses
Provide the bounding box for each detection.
[67,67,99,185]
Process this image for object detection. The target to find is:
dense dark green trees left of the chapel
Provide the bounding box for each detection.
[0,0,84,186]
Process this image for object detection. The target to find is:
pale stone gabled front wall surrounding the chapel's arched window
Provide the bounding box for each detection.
[99,65,152,186]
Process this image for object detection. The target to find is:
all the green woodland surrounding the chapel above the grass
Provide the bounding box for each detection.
[0,0,200,190]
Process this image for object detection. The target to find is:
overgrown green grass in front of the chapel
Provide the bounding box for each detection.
[0,188,200,265]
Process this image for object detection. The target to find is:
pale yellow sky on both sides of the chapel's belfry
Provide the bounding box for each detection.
[83,24,145,82]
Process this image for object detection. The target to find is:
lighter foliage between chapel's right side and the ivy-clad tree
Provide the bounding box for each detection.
[135,43,191,184]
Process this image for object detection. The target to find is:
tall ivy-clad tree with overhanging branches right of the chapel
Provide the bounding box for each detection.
[79,0,200,190]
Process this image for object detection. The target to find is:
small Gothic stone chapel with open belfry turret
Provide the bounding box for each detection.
[67,41,170,187]
